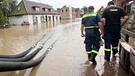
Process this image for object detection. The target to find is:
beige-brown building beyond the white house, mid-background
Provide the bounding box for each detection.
[58,6,76,19]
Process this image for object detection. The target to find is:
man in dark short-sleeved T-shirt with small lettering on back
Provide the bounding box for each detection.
[102,1,128,61]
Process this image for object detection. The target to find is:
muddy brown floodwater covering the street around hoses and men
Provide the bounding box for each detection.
[0,19,128,76]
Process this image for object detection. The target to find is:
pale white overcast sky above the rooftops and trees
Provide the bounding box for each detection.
[18,0,111,10]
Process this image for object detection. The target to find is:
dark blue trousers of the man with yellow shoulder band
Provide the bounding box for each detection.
[84,29,100,55]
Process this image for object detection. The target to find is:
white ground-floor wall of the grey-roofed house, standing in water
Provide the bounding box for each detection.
[9,15,60,25]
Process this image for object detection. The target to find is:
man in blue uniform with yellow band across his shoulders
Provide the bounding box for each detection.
[81,6,103,64]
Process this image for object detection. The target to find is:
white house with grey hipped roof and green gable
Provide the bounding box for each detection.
[9,0,60,25]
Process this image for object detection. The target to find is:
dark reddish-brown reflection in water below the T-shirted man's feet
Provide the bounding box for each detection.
[101,56,128,76]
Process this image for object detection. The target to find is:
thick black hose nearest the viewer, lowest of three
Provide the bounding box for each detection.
[0,40,57,72]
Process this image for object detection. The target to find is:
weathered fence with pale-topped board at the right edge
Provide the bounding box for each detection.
[119,28,135,76]
